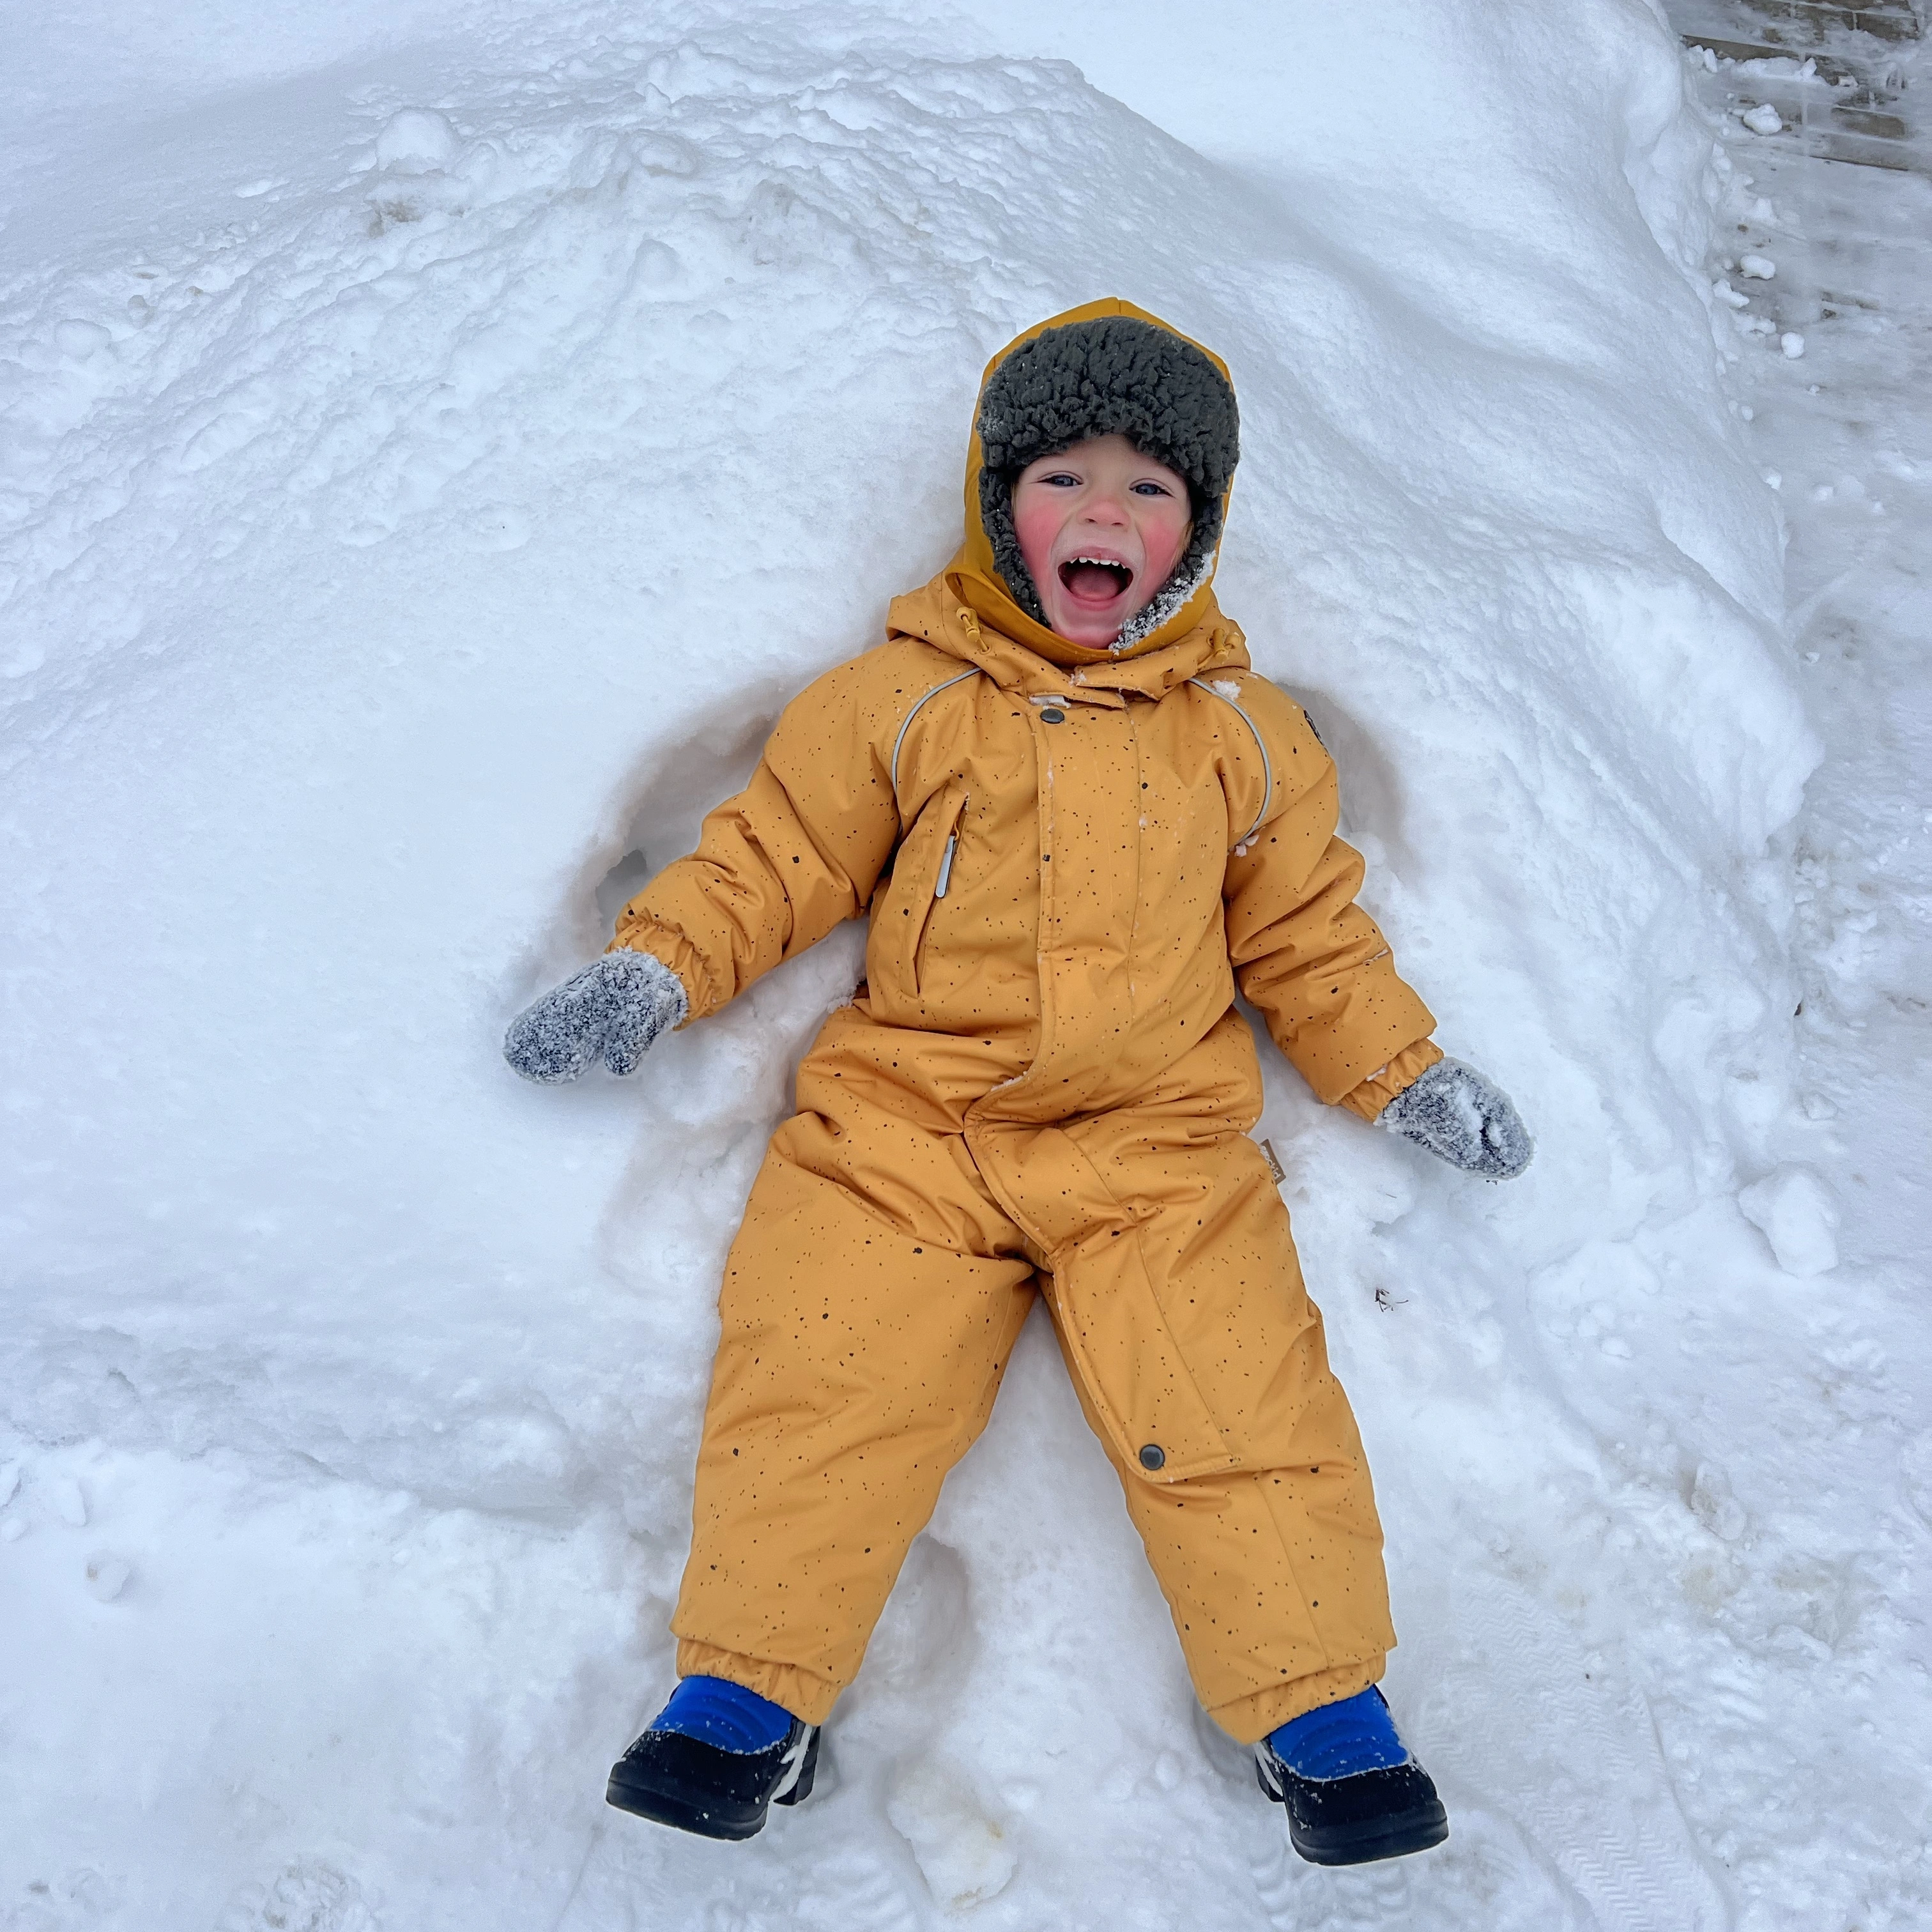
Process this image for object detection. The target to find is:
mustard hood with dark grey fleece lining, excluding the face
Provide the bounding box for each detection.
[945,296,1246,668]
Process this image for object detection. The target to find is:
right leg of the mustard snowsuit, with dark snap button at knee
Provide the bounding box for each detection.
[974,1016,1395,1743]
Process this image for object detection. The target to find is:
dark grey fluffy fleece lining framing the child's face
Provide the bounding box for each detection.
[979,315,1240,651]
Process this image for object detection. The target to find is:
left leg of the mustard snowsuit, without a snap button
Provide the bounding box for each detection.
[672,1015,1034,1723]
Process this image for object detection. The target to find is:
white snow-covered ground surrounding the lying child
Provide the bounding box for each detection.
[0,0,1932,1932]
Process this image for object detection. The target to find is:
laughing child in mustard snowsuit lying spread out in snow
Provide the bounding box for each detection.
[504,302,1530,1864]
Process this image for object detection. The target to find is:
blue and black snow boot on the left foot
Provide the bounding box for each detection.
[605,1677,819,1837]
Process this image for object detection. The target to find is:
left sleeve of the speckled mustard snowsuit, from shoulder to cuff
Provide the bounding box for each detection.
[611,664,900,1020]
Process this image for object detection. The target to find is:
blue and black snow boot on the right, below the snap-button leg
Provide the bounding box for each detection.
[1254,1685,1449,1864]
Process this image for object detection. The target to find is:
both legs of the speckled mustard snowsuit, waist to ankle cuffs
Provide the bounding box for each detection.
[672,1016,1395,1743]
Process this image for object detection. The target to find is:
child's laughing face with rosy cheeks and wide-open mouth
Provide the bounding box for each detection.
[1013,436,1194,649]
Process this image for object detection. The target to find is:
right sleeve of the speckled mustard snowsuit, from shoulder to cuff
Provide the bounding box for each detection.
[1223,674,1441,1121]
